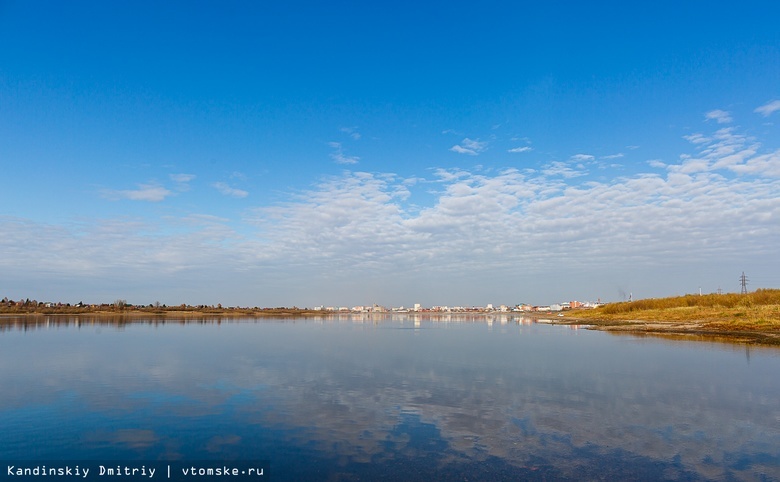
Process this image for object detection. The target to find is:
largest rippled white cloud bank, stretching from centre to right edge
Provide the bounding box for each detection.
[245,159,780,294]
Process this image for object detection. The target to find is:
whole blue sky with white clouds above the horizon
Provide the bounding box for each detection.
[0,0,780,307]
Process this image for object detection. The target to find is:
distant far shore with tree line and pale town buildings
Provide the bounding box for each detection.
[0,297,603,313]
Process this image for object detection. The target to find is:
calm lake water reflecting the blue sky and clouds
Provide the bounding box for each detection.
[0,316,780,481]
